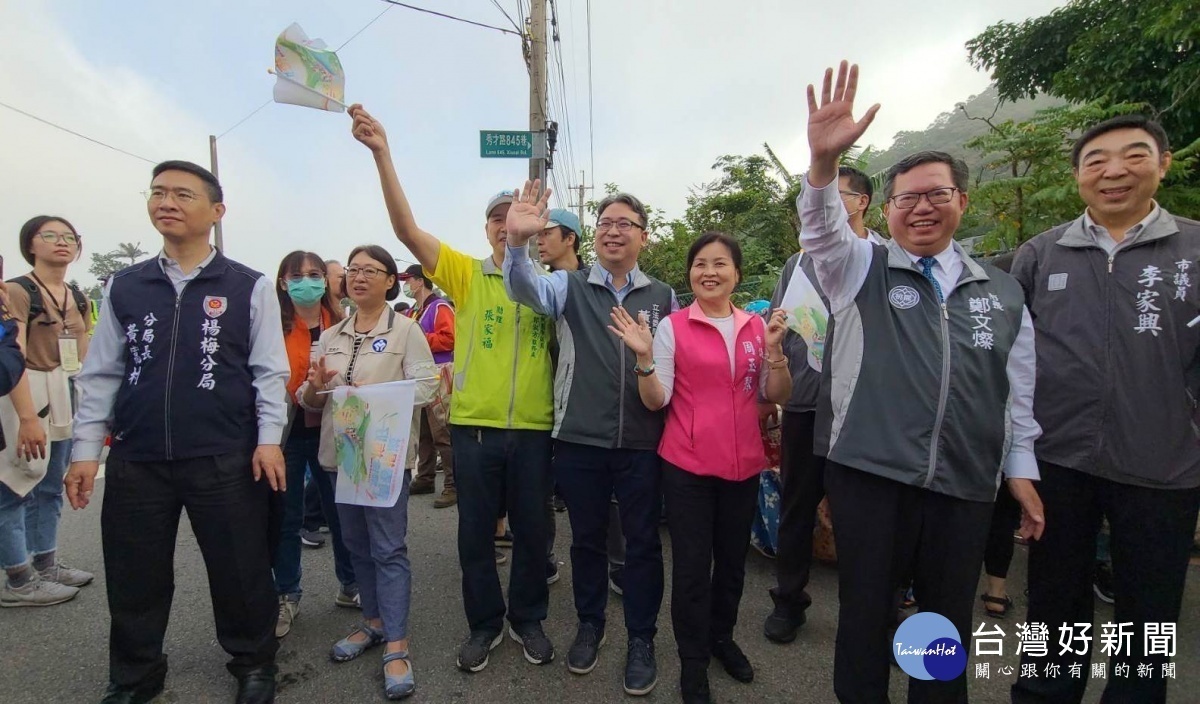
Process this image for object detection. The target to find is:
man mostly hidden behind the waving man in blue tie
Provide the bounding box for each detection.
[762,167,883,643]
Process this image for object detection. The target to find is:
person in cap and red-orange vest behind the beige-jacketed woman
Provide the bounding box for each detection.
[400,264,458,509]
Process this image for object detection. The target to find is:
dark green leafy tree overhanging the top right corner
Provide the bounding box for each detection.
[966,0,1200,146]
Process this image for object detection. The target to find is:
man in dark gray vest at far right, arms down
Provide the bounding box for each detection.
[1013,115,1200,703]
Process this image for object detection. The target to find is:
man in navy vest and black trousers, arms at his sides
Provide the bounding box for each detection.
[65,161,289,704]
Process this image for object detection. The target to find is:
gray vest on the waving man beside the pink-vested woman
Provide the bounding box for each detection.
[554,267,672,450]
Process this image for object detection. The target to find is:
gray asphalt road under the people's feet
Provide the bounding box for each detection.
[0,474,1200,704]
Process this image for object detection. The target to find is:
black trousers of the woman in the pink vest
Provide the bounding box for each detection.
[662,462,758,663]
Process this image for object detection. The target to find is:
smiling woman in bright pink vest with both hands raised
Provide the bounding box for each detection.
[610,233,792,704]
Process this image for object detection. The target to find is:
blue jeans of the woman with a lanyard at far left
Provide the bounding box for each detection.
[0,440,71,570]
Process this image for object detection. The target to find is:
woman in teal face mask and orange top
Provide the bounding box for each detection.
[274,251,358,638]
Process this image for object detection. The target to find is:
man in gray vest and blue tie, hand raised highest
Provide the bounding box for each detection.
[797,61,1044,703]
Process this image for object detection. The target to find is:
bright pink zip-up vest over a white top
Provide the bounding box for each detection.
[659,303,767,481]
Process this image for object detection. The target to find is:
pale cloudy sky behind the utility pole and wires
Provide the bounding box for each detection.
[0,0,1063,293]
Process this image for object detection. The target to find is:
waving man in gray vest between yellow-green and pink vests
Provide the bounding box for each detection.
[504,182,678,696]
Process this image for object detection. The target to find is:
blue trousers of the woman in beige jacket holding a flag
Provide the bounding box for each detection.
[330,470,413,640]
